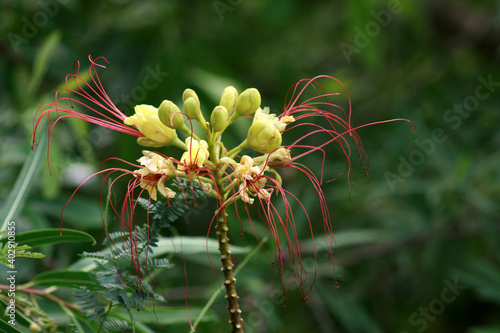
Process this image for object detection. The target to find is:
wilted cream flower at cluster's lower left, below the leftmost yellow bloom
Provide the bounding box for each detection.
[135,150,175,200]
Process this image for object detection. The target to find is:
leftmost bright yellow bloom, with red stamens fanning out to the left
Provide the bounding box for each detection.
[123,104,177,147]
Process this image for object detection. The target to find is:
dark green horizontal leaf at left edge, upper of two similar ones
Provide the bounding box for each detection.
[0,229,96,247]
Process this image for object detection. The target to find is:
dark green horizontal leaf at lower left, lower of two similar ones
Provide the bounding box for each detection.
[32,270,95,289]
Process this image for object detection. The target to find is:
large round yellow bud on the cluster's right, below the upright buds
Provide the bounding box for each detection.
[247,119,281,154]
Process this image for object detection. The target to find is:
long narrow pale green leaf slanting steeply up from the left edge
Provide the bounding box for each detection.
[0,131,48,230]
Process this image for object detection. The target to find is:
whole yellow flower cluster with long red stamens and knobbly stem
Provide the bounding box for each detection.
[33,57,414,330]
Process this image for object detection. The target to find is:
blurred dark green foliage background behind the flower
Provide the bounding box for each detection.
[0,0,500,333]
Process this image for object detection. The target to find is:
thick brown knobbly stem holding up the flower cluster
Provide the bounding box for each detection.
[216,203,243,333]
